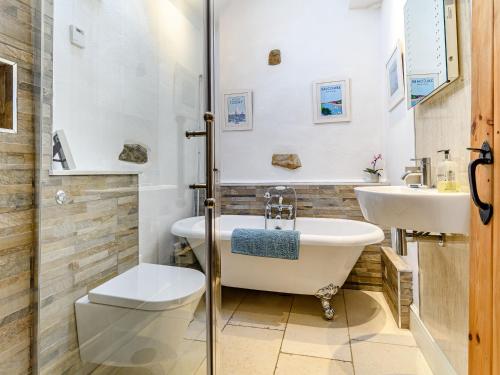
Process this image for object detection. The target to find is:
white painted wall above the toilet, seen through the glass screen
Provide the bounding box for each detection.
[53,0,203,263]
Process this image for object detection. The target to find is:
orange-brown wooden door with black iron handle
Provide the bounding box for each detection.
[469,0,500,375]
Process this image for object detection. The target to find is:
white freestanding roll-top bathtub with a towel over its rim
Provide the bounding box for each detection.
[171,215,384,295]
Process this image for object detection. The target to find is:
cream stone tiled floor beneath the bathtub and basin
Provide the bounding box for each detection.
[185,288,432,375]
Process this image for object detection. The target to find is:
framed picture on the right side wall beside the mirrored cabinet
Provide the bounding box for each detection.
[385,42,405,111]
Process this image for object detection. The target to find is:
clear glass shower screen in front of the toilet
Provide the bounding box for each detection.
[34,0,218,375]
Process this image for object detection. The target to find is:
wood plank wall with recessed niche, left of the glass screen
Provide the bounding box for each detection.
[0,0,35,375]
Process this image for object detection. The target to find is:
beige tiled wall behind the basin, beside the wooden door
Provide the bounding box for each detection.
[415,0,472,375]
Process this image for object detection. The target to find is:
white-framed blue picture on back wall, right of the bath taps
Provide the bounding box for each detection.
[313,79,351,124]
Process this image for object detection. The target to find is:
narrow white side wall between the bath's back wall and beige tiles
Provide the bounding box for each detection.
[380,0,419,309]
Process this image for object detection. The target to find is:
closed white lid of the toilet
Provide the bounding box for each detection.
[88,263,205,311]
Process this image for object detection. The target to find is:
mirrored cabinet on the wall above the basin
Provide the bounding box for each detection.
[405,0,459,108]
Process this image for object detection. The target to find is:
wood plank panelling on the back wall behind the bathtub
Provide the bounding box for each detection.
[221,185,390,292]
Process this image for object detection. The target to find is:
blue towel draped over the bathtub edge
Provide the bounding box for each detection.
[231,229,300,260]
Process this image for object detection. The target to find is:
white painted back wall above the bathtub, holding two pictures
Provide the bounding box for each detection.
[218,0,385,183]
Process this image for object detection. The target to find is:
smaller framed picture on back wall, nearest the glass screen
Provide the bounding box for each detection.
[222,90,253,131]
